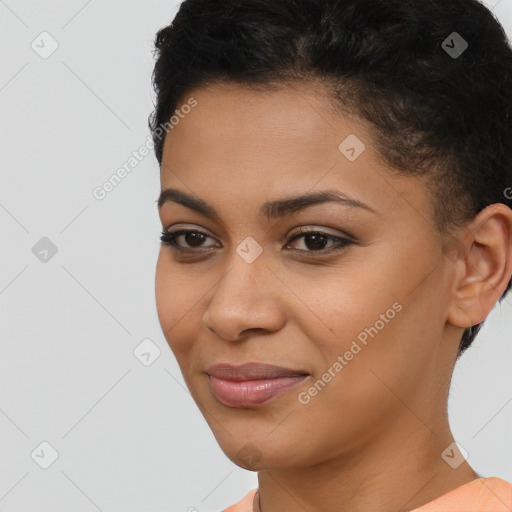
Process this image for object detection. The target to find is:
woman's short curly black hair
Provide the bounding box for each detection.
[149,0,512,357]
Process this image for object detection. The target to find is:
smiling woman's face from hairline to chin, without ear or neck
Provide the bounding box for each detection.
[156,80,461,470]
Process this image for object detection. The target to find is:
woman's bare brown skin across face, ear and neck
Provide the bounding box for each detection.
[156,82,512,512]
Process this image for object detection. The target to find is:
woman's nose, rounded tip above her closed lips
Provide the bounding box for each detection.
[203,249,286,341]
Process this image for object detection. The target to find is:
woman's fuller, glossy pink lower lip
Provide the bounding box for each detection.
[208,375,308,407]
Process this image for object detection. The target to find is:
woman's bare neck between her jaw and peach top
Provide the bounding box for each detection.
[254,410,479,512]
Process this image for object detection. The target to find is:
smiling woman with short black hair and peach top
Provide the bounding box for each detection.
[150,0,512,512]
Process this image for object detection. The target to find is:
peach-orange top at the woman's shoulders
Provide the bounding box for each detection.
[222,476,512,512]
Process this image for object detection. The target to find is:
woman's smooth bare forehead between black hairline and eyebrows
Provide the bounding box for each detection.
[161,83,436,229]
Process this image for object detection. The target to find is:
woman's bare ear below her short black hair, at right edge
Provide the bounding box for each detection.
[447,203,512,328]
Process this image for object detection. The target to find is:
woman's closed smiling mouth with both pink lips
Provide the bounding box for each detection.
[206,363,310,408]
